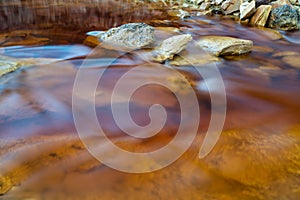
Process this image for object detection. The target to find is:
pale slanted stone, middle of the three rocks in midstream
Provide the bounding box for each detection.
[152,34,193,62]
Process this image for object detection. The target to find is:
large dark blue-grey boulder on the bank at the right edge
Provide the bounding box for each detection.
[268,5,299,30]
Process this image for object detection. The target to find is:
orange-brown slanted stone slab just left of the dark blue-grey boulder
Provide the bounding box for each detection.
[250,5,272,26]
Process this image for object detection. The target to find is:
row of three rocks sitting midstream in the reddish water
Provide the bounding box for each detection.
[88,23,253,65]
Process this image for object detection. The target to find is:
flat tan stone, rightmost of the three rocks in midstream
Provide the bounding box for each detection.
[198,36,253,56]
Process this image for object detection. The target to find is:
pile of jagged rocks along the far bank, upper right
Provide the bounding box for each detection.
[159,0,300,30]
